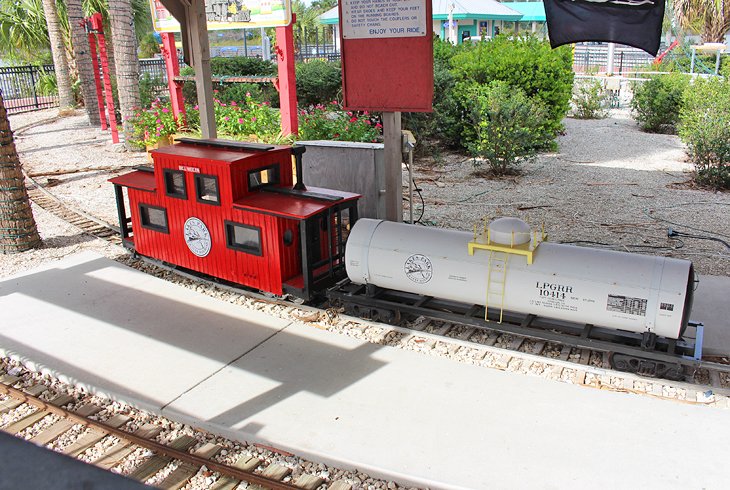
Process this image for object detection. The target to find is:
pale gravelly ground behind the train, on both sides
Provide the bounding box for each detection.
[0,110,730,277]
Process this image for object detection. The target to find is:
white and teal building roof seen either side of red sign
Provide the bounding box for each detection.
[319,0,524,24]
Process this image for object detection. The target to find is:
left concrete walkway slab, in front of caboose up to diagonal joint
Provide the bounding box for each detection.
[0,252,288,410]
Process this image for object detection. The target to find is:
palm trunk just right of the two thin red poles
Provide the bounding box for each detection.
[109,0,140,149]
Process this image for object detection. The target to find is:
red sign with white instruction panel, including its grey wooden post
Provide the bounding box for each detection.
[339,0,433,221]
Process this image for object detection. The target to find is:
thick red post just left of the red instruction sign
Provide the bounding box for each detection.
[276,14,299,136]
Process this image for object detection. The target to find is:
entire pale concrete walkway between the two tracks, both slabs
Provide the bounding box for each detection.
[0,254,730,489]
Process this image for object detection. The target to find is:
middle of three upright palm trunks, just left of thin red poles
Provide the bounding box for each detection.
[66,0,101,126]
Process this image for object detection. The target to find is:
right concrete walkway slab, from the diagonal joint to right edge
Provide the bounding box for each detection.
[163,325,730,489]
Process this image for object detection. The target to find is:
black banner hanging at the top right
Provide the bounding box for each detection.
[544,0,664,56]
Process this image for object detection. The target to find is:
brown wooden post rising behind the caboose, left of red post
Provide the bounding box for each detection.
[185,0,218,139]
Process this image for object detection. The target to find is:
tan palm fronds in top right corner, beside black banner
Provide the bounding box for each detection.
[671,0,730,43]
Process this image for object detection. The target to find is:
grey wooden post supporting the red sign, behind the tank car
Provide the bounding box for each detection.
[383,112,403,222]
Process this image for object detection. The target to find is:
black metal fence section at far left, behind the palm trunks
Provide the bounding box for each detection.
[0,65,58,114]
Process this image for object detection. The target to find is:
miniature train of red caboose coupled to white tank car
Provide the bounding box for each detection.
[111,139,702,378]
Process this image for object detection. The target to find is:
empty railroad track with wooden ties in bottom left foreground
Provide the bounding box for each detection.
[0,373,351,490]
